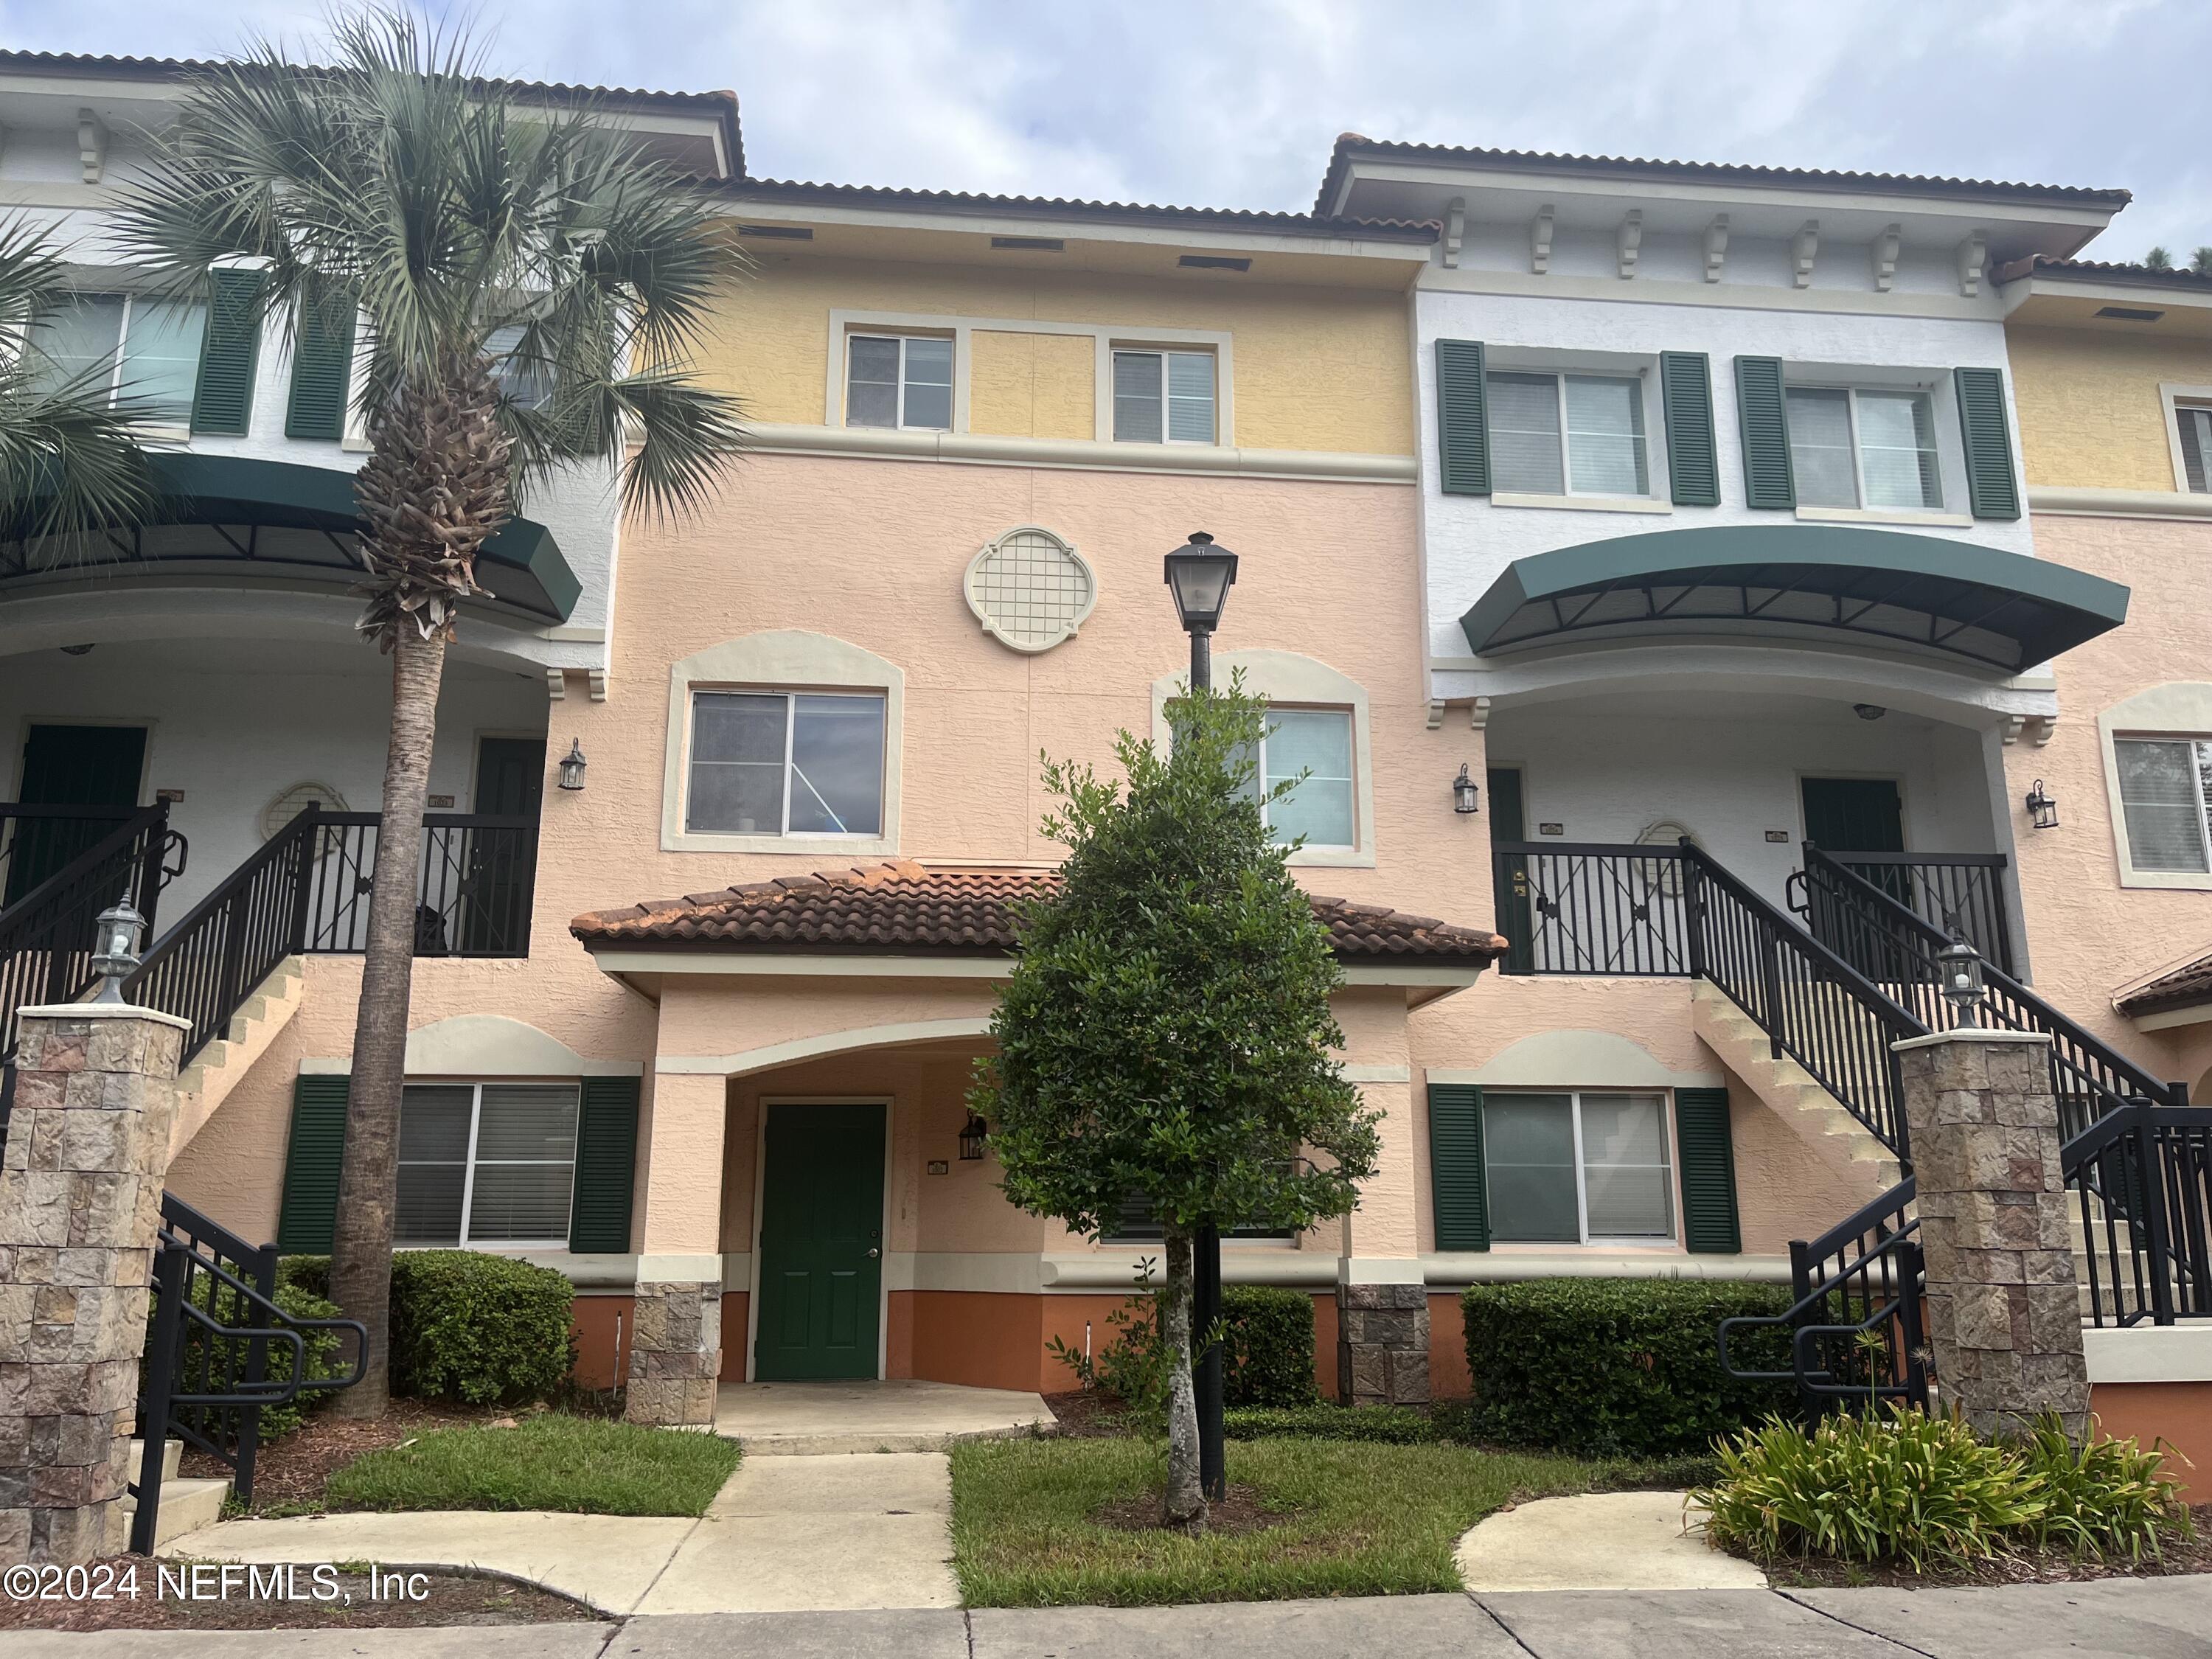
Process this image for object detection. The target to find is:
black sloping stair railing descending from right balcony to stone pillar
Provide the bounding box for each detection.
[1683,845,1929,1166]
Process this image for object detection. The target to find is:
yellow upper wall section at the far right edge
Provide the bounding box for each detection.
[2006,325,2212,489]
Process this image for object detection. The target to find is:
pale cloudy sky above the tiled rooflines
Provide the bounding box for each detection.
[0,0,2212,261]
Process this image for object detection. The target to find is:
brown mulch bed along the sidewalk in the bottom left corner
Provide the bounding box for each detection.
[0,1555,599,1630]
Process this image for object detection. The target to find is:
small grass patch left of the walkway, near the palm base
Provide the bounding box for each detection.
[323,1411,739,1515]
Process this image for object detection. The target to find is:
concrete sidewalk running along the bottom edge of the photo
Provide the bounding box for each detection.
[7,1564,2212,1659]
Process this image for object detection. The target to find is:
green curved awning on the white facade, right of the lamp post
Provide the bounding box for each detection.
[1460,524,2128,672]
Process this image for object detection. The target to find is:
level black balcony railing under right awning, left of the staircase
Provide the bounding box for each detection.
[1491,841,1690,978]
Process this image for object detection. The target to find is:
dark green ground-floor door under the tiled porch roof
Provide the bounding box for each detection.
[754,1106,883,1382]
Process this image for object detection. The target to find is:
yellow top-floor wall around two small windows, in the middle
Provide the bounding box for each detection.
[699,254,1413,456]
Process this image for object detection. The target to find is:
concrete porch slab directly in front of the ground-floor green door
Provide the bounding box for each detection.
[714,1380,1053,1458]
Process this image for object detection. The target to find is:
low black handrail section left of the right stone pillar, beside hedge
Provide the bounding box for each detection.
[1721,1175,1929,1418]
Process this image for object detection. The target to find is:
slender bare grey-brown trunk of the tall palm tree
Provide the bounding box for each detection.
[330,628,445,1418]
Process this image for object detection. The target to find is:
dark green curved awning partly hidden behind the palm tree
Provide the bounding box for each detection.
[0,451,584,622]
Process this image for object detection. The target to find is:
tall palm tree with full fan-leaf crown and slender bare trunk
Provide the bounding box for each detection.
[117,11,745,1416]
